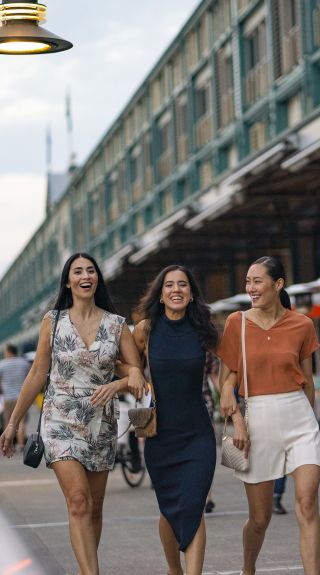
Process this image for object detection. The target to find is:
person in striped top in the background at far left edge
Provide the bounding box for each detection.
[0,343,30,451]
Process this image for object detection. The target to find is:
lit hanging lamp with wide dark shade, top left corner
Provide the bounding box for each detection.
[0,0,72,55]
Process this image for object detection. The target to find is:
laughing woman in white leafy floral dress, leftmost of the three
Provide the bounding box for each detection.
[0,253,144,575]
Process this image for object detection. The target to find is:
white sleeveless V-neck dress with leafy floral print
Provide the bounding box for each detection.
[41,310,125,471]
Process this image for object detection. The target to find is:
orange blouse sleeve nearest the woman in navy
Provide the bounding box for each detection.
[217,312,241,372]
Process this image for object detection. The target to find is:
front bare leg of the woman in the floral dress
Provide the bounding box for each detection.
[52,460,99,575]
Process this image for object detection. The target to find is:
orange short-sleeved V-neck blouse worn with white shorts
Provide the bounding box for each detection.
[217,310,319,396]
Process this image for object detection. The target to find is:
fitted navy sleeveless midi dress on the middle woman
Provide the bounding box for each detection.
[145,316,216,551]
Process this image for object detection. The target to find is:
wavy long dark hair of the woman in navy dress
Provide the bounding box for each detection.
[135,265,218,349]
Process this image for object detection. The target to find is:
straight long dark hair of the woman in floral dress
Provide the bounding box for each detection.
[54,252,117,313]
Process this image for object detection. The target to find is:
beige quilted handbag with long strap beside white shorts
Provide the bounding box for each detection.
[221,312,250,471]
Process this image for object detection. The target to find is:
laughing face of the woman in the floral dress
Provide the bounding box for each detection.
[67,257,98,299]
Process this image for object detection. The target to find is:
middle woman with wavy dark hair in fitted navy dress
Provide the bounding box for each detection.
[134,265,217,575]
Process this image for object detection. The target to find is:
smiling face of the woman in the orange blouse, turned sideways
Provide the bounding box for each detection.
[246,264,284,308]
